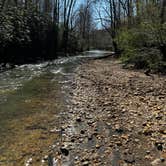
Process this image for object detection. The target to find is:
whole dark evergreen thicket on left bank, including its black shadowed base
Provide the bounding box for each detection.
[0,6,58,63]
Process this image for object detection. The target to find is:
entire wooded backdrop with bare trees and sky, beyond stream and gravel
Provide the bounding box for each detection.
[0,0,166,72]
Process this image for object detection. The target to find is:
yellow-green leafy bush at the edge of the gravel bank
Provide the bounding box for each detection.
[116,22,166,72]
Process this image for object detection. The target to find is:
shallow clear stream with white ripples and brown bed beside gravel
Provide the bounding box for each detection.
[0,51,113,166]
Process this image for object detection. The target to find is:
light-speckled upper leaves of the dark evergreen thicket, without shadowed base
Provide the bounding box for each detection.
[0,7,51,45]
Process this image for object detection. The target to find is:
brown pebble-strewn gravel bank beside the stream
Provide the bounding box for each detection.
[56,59,166,166]
